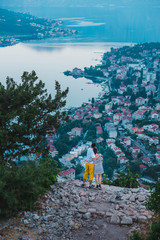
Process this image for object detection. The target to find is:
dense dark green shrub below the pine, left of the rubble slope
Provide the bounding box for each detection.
[0,159,57,218]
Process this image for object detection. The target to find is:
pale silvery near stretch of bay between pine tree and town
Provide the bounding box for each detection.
[0,41,128,107]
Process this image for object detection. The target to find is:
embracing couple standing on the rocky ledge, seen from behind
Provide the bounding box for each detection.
[82,143,104,189]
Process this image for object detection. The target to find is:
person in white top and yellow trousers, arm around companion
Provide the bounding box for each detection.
[82,143,102,188]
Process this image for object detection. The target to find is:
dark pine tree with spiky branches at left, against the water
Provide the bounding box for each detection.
[0,71,68,162]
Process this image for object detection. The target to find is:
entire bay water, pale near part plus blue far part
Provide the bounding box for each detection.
[0,0,160,106]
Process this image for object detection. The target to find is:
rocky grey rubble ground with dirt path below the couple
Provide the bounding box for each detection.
[0,180,153,240]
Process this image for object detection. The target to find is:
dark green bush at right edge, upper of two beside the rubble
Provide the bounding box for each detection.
[147,180,160,213]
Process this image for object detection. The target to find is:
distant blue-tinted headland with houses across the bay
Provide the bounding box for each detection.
[0,8,77,47]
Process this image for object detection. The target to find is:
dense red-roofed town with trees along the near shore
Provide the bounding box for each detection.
[54,43,160,187]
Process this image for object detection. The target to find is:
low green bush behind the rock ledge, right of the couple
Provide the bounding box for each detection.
[113,169,139,188]
